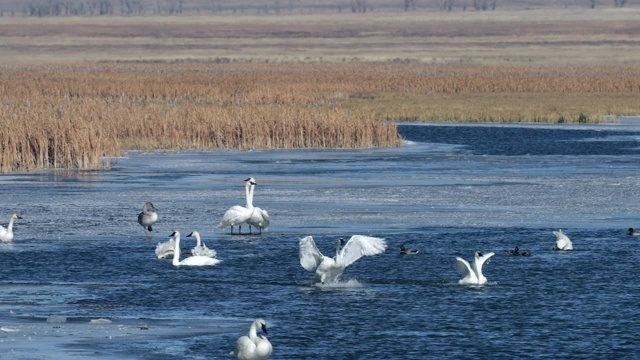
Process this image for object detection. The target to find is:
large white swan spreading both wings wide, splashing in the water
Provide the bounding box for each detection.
[299,235,387,284]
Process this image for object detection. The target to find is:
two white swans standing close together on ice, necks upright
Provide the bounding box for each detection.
[218,177,269,235]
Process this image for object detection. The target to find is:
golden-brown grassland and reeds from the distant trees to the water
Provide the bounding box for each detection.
[0,4,640,172]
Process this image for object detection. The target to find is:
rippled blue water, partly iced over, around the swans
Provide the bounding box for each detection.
[0,124,640,359]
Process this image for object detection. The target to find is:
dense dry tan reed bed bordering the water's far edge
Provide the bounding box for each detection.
[0,63,640,172]
